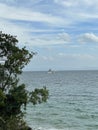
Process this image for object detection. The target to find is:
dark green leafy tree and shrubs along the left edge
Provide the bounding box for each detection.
[0,32,49,130]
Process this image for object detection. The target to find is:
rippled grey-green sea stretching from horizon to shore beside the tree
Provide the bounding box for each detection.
[20,70,98,130]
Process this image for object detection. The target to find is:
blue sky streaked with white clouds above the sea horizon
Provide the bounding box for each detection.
[0,0,98,71]
